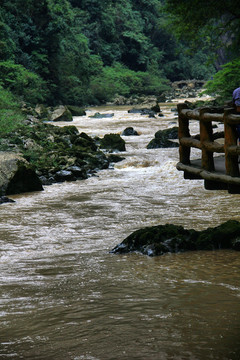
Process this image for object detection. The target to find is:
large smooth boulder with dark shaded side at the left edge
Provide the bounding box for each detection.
[0,152,43,196]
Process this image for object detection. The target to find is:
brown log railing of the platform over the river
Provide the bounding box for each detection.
[177,104,240,193]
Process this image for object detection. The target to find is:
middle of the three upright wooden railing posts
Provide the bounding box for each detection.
[200,108,215,171]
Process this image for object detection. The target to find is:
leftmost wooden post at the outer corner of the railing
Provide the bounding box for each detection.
[177,104,191,165]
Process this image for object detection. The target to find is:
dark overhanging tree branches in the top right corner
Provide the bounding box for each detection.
[164,0,240,63]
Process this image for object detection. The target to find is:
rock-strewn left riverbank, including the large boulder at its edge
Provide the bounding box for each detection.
[0,111,125,196]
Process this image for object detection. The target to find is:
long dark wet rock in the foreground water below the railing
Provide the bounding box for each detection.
[111,220,240,256]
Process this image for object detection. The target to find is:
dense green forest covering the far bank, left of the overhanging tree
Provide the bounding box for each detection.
[0,0,213,105]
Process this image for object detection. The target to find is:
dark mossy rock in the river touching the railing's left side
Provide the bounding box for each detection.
[147,126,179,149]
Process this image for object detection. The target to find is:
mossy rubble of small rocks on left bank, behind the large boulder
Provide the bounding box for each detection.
[0,117,125,186]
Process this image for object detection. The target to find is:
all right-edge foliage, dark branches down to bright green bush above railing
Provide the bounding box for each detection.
[164,0,240,101]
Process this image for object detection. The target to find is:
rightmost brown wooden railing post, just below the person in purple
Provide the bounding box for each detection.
[224,109,240,176]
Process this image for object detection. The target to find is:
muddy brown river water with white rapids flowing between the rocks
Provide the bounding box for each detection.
[0,105,240,360]
